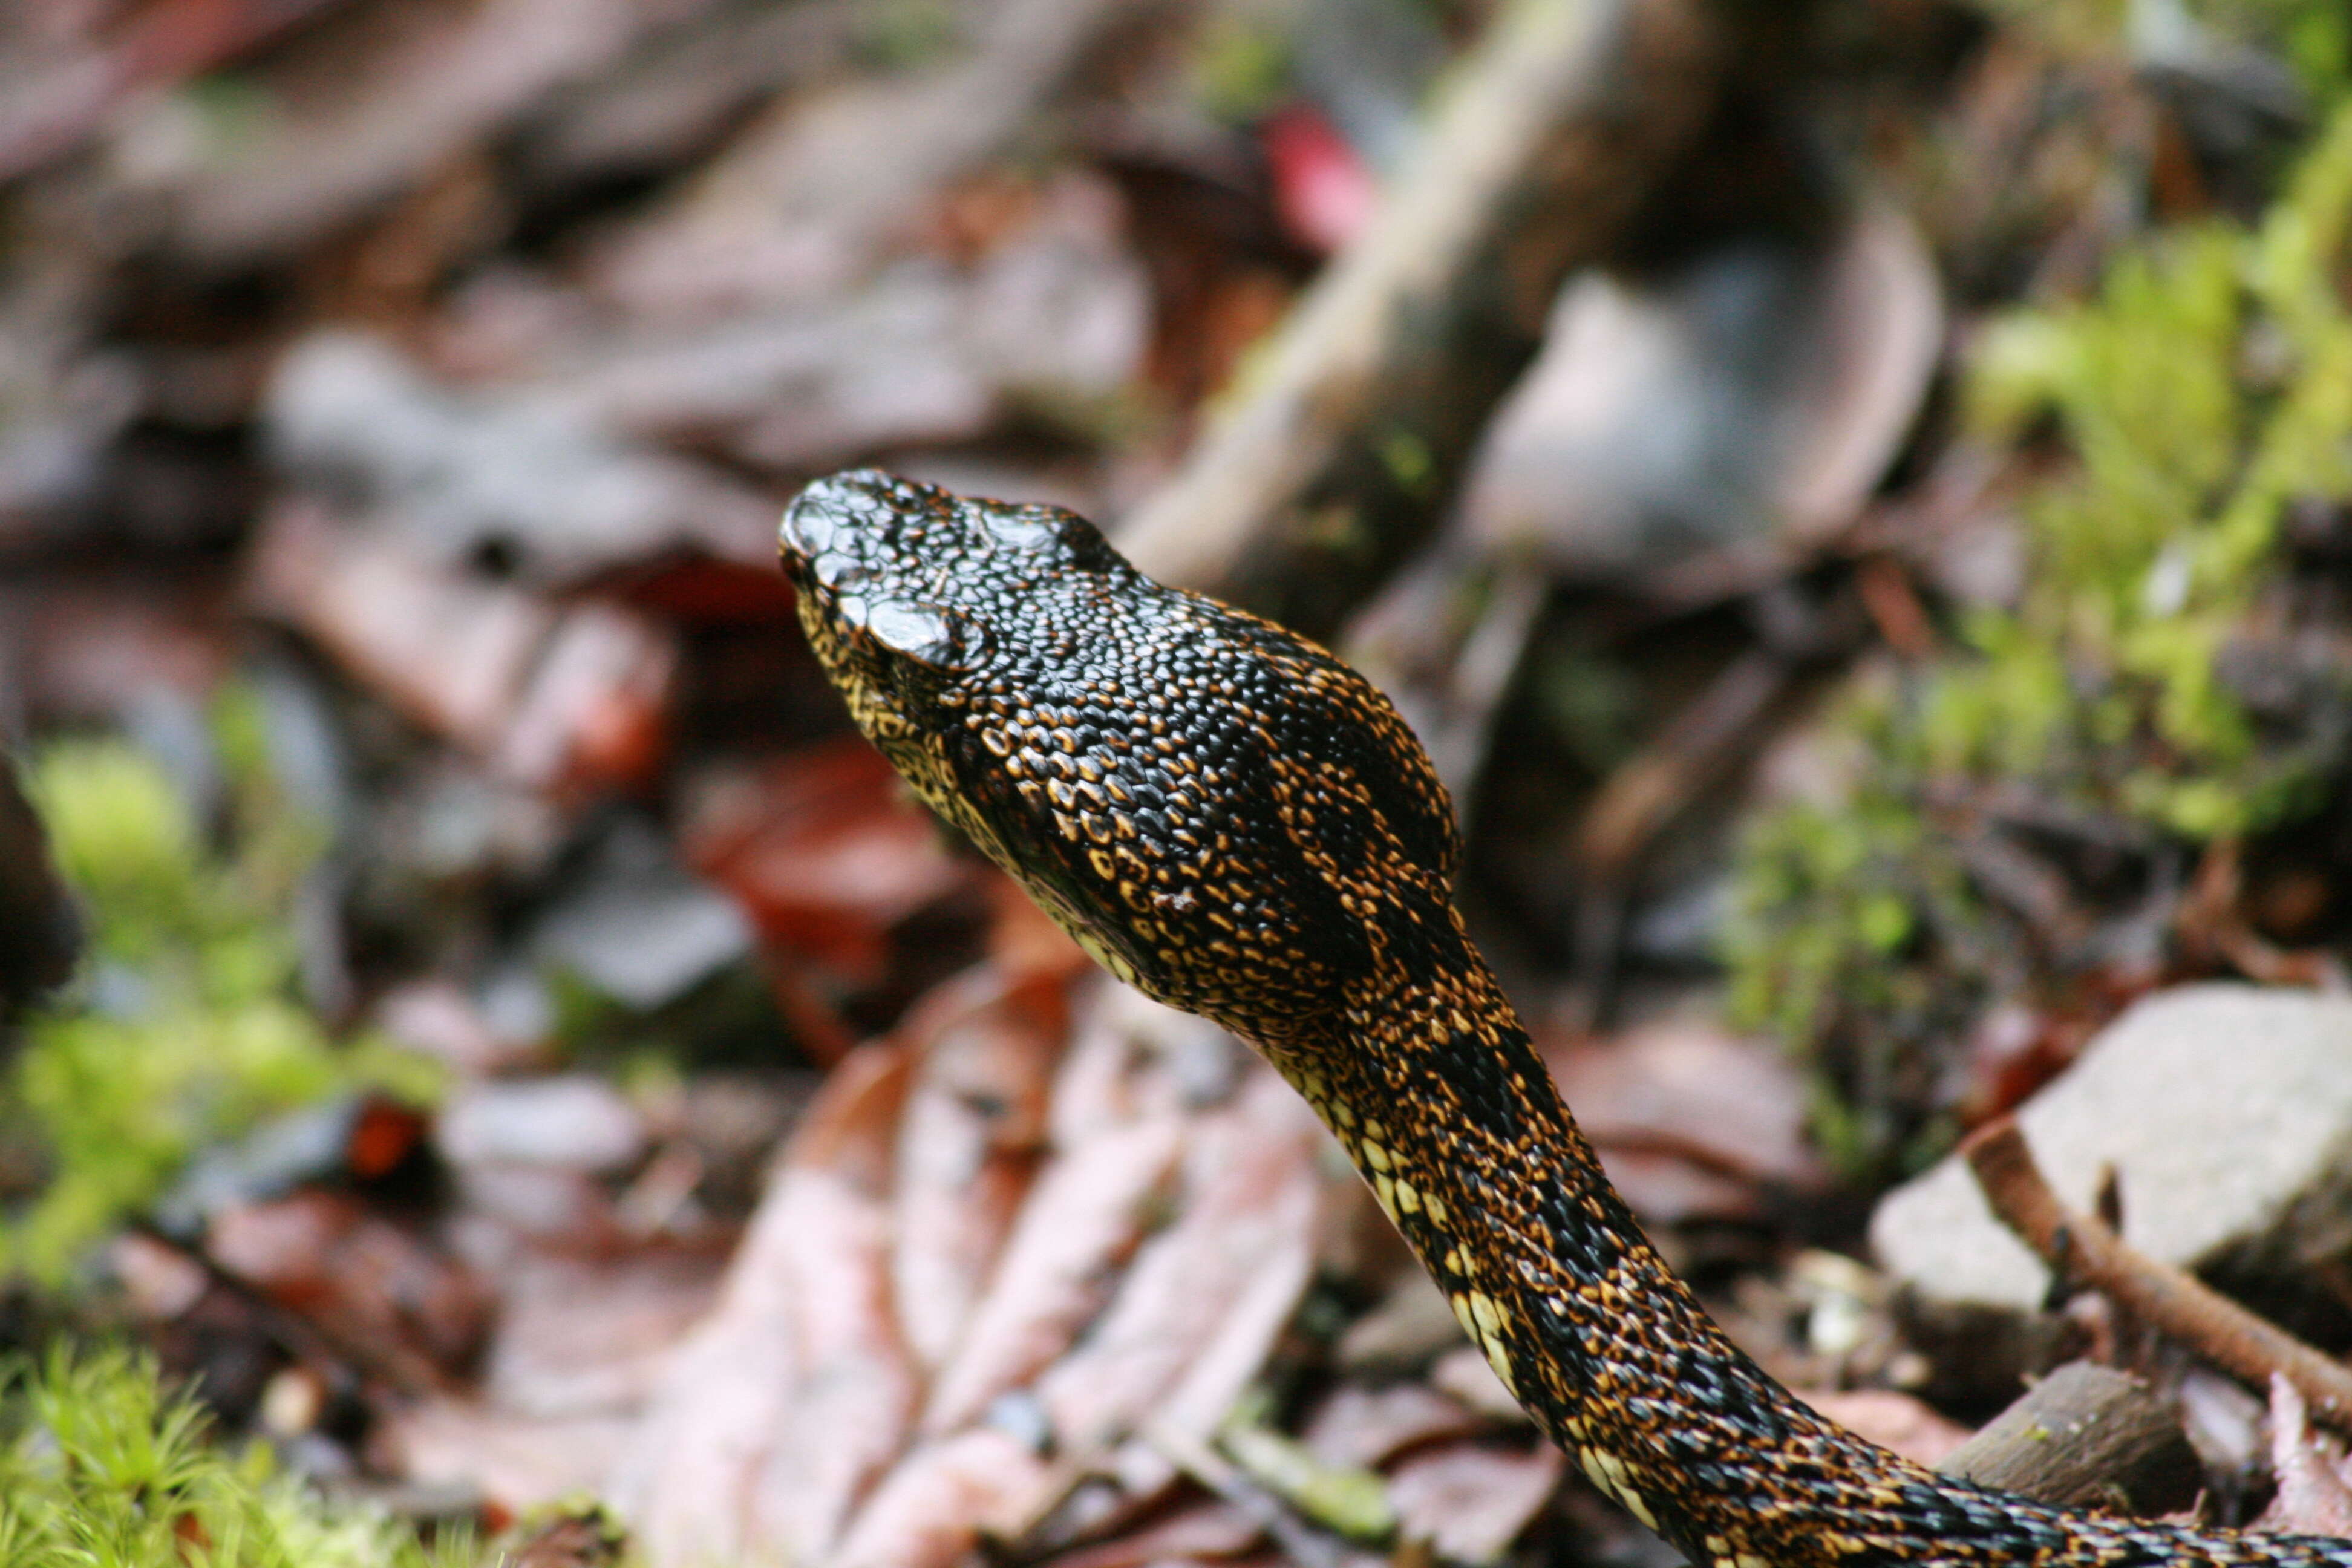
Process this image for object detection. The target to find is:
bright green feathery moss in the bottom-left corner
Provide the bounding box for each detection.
[0,1350,475,1568]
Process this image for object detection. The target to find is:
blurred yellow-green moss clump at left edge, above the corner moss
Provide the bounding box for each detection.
[0,696,433,1284]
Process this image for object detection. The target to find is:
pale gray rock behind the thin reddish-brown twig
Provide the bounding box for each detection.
[1870,985,2352,1314]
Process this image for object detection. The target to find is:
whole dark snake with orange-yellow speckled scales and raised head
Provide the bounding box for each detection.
[781,470,2352,1568]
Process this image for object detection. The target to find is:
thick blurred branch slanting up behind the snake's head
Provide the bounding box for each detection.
[1120,0,1731,632]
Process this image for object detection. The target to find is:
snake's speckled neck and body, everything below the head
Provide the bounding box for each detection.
[1261,917,2352,1568]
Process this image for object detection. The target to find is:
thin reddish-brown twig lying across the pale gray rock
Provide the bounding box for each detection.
[1962,1117,2352,1432]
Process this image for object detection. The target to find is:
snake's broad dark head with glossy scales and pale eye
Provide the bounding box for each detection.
[781,470,1459,1037]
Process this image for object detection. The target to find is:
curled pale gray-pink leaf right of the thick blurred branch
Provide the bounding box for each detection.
[1460,207,1942,576]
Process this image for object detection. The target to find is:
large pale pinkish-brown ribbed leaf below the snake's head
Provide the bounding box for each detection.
[616,969,1343,1566]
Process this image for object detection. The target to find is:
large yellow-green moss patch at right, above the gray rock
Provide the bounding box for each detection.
[1729,98,2352,1168]
